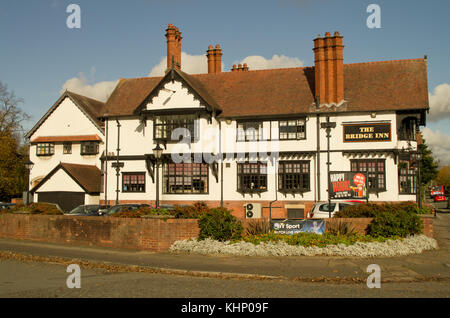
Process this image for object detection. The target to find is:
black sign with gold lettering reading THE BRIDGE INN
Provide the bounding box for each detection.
[343,123,391,142]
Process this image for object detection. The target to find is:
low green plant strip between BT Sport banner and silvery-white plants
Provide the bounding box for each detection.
[242,232,392,247]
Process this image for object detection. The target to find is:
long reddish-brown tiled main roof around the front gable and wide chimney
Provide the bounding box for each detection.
[105,59,429,117]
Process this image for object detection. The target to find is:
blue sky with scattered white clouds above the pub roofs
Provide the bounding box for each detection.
[0,0,450,164]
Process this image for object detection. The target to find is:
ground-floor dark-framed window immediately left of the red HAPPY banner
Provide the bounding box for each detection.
[278,160,311,193]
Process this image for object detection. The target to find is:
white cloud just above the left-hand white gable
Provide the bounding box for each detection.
[61,69,118,102]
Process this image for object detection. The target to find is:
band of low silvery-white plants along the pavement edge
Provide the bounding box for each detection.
[169,235,438,257]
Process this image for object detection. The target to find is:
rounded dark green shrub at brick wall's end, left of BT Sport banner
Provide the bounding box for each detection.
[198,208,243,241]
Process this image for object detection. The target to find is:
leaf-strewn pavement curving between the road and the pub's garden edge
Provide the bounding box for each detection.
[0,213,450,285]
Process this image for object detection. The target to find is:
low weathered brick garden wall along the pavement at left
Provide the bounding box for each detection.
[0,214,199,252]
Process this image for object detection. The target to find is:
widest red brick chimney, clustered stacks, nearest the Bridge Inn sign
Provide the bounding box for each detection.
[313,32,344,104]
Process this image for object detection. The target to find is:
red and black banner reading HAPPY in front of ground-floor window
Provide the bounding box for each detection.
[328,171,367,199]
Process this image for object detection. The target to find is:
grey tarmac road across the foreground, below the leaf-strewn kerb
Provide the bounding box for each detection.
[0,260,450,298]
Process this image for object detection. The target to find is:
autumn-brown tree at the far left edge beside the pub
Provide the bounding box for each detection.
[0,82,30,201]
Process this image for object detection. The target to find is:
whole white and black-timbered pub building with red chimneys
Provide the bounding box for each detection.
[27,24,429,218]
